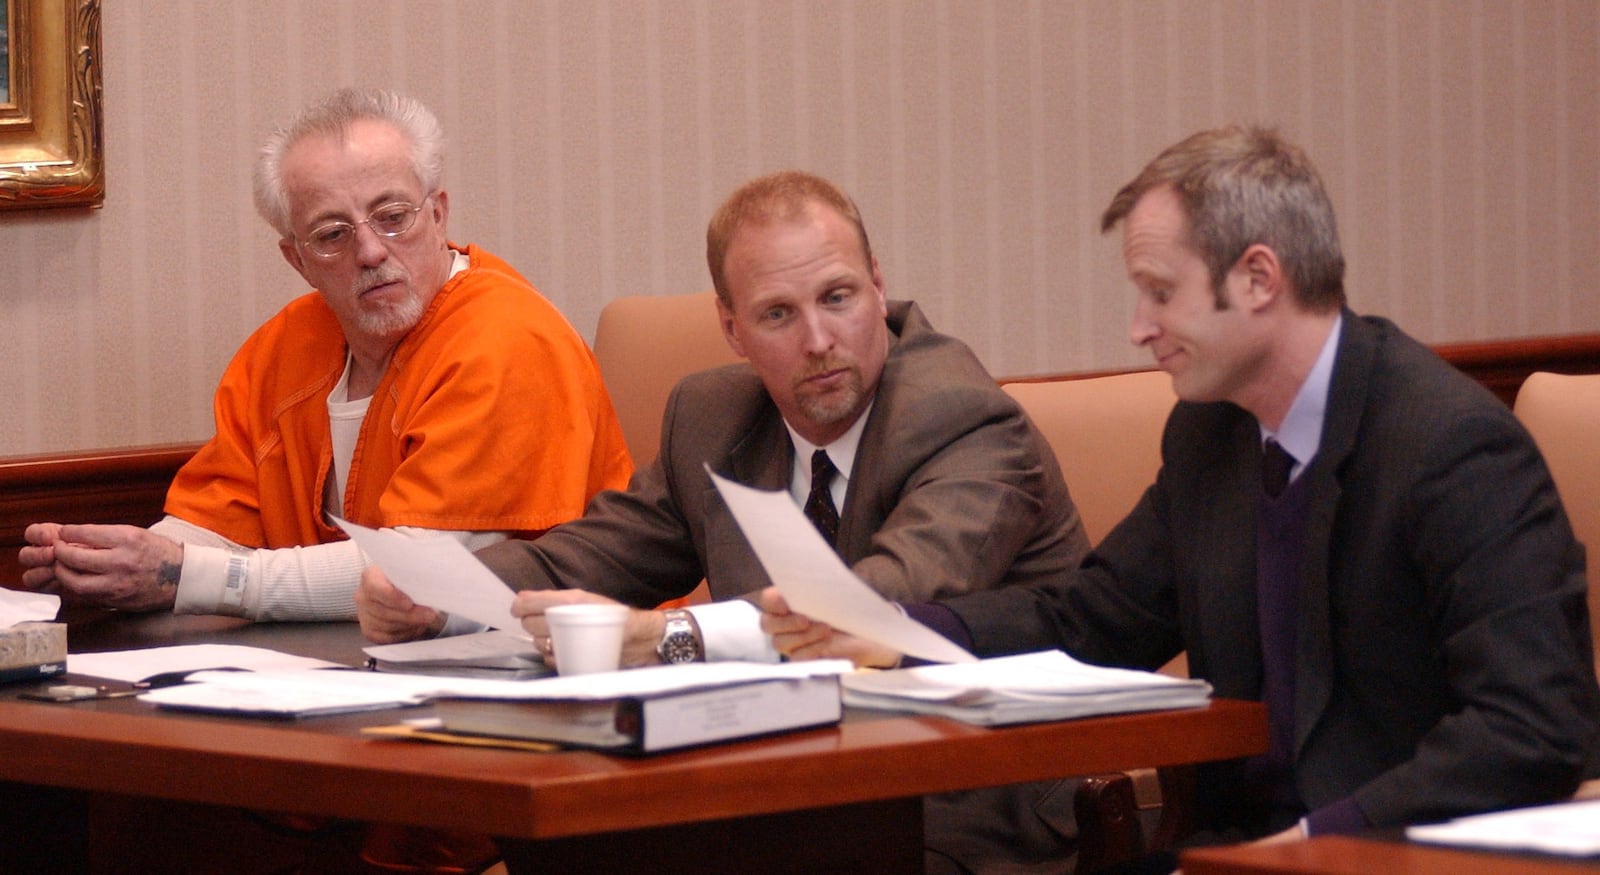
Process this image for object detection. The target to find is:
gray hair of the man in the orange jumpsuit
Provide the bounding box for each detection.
[254,88,445,237]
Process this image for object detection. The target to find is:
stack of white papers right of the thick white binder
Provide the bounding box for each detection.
[845,651,1211,726]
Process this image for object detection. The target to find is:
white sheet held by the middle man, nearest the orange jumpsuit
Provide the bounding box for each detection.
[333,518,522,633]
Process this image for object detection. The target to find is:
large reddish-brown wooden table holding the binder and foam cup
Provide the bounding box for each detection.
[0,614,1267,872]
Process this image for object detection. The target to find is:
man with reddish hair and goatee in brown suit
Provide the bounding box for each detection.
[357,173,1088,867]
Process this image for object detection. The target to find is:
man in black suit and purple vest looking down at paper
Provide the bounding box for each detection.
[762,128,1600,863]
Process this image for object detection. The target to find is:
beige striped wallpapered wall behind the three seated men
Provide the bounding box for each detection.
[0,0,1600,454]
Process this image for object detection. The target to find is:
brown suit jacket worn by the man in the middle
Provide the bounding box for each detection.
[478,302,1088,606]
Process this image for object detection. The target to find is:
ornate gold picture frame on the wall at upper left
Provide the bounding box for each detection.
[0,0,106,210]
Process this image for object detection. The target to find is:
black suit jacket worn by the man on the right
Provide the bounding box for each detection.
[949,312,1600,833]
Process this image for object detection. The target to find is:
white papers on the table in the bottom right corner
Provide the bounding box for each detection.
[1405,800,1600,857]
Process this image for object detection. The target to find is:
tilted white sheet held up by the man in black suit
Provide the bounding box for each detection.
[706,467,976,662]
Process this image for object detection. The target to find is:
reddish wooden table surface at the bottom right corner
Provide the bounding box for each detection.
[1182,835,1600,875]
